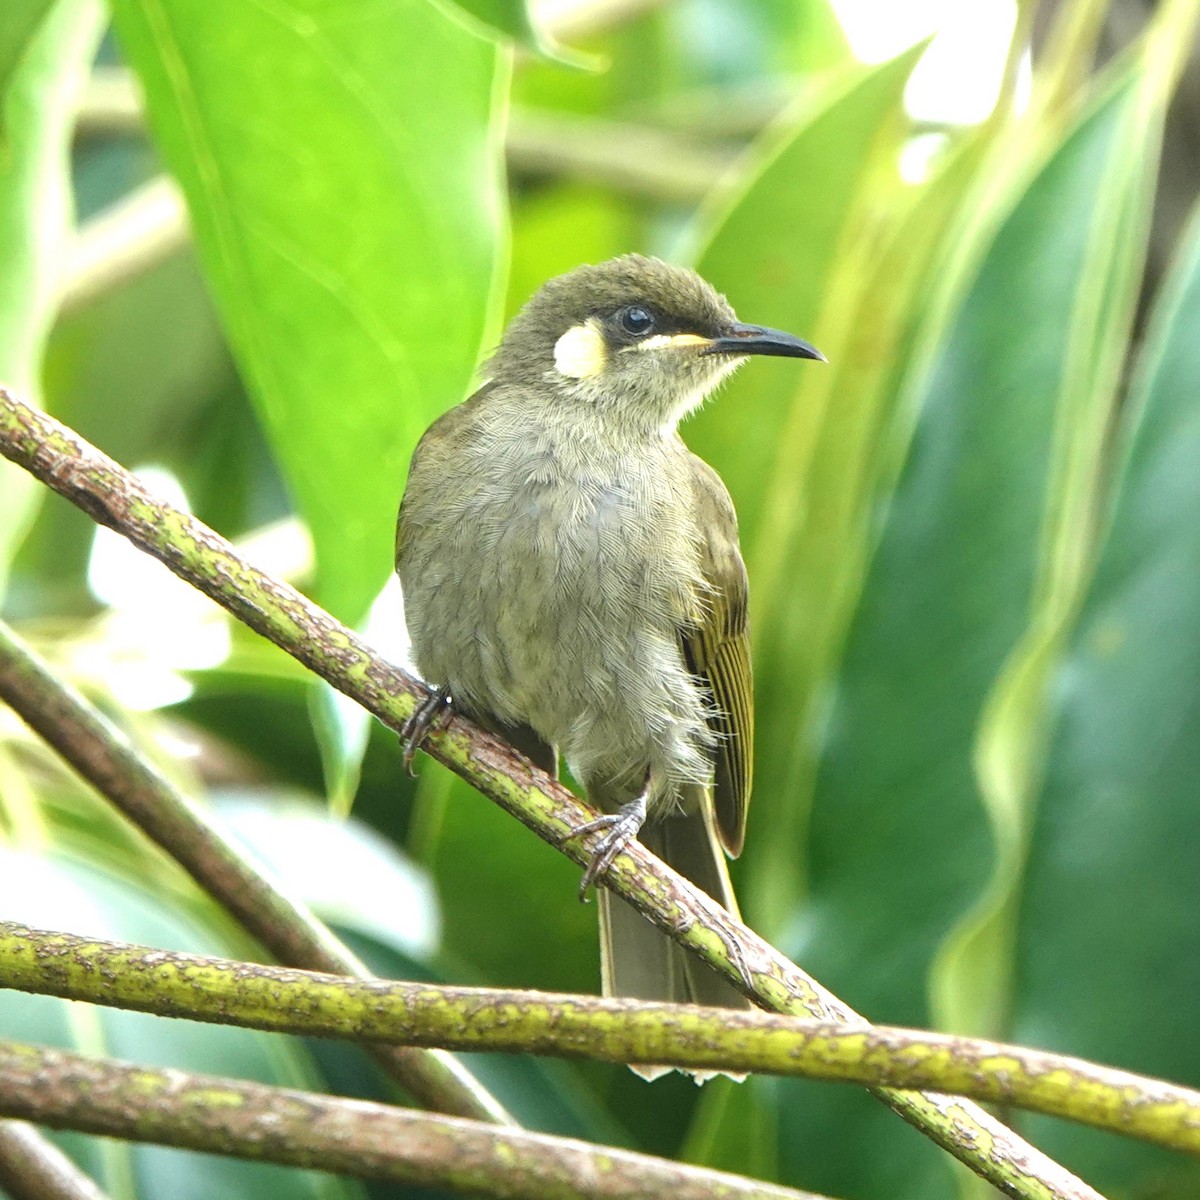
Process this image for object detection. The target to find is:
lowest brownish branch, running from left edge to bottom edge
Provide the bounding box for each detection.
[0,1042,820,1200]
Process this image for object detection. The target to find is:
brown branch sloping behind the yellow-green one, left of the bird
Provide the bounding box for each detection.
[0,622,511,1123]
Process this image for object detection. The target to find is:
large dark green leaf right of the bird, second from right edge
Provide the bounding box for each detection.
[748,58,1152,1196]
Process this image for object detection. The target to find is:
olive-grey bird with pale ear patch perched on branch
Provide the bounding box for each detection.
[396,254,824,1008]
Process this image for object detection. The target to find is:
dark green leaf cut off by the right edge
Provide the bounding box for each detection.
[1012,192,1200,1198]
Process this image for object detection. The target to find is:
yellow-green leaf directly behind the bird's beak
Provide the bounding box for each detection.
[685,50,921,935]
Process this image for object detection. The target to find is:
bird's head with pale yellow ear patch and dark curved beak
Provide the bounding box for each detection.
[491,254,823,430]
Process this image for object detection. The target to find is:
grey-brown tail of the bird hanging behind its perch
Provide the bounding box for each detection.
[600,796,750,1022]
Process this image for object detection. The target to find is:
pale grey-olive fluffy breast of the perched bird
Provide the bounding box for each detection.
[402,439,703,744]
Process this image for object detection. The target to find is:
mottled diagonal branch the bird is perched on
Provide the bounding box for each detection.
[0,388,1098,1200]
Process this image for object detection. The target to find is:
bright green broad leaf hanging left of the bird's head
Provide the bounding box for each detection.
[104,0,506,622]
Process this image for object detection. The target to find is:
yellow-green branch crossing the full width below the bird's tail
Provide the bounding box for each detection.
[0,922,1200,1153]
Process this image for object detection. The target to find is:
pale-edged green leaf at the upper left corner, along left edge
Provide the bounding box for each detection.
[0,0,101,594]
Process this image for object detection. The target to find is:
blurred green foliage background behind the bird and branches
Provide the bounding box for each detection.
[0,0,1200,1200]
